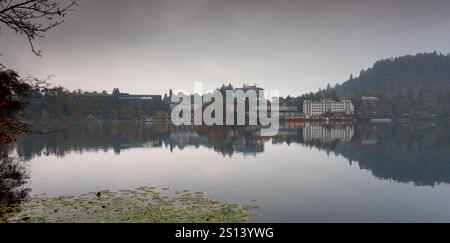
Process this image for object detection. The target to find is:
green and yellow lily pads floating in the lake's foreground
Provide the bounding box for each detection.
[0,187,258,223]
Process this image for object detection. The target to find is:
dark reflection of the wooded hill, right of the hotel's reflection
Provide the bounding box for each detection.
[342,124,450,186]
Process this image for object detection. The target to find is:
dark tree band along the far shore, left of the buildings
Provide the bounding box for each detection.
[25,87,168,121]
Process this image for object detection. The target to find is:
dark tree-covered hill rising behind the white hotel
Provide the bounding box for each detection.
[332,53,450,117]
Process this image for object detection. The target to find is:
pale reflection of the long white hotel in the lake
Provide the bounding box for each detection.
[303,123,355,142]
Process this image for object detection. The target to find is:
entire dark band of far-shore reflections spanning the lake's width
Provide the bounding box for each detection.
[12,122,450,185]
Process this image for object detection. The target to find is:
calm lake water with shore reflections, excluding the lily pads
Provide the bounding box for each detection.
[7,122,450,222]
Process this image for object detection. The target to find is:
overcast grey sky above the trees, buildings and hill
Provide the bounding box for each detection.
[0,0,450,95]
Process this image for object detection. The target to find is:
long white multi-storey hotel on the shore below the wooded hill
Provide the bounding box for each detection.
[303,99,355,117]
